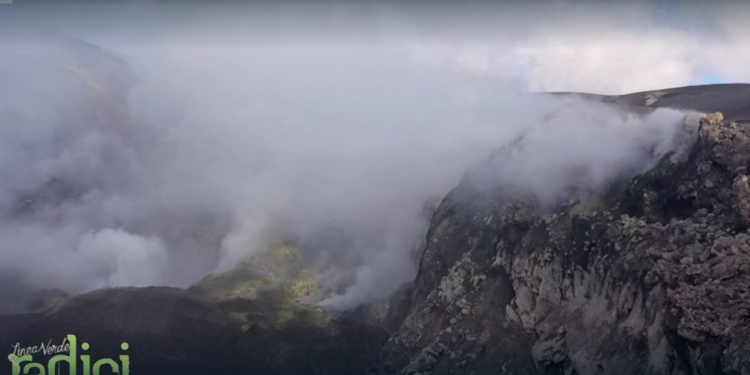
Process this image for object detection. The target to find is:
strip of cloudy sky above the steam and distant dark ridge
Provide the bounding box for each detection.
[6,0,750,94]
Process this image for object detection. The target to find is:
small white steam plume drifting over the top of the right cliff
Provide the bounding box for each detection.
[472,100,698,205]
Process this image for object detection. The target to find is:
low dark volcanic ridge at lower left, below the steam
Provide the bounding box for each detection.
[0,287,387,375]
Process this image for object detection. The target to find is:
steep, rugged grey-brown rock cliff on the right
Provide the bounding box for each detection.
[380,114,750,375]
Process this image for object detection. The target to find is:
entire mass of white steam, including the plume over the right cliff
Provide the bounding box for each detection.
[0,5,716,308]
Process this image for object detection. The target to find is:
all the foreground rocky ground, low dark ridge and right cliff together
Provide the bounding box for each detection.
[0,107,750,375]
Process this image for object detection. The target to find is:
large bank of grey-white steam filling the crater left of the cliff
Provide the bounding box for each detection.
[0,26,536,303]
